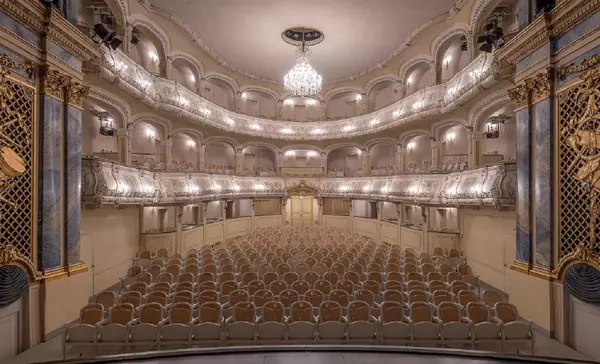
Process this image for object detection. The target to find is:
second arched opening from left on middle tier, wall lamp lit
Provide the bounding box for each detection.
[131,120,166,168]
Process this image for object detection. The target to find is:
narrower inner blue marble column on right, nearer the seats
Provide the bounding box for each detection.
[517,108,531,263]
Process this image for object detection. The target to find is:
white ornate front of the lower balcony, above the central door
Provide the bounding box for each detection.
[82,158,517,208]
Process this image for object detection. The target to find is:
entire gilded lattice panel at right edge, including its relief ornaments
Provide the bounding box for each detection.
[554,65,600,278]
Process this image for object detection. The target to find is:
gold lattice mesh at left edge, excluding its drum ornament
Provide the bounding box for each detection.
[0,78,35,262]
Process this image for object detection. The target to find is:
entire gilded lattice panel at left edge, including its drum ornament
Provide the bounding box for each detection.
[0,54,41,281]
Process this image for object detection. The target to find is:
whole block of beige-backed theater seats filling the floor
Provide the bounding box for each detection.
[64,227,533,353]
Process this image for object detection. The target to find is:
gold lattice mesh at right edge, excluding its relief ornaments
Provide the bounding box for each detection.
[558,83,600,260]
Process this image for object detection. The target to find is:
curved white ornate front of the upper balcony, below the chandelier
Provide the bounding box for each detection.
[97,51,500,140]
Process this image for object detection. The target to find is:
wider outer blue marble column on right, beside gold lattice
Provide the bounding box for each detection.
[533,98,554,267]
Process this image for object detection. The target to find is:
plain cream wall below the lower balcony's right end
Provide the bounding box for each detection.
[460,209,516,292]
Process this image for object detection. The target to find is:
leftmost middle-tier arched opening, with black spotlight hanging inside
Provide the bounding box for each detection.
[81,99,125,162]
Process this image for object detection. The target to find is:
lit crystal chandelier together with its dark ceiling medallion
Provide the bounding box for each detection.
[281,27,325,96]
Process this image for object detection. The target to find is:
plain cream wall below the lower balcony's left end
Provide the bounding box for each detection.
[44,207,140,334]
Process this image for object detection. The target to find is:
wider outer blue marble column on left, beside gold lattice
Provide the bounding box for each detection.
[38,96,63,269]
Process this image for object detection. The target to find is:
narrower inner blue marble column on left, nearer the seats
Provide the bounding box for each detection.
[65,106,82,264]
